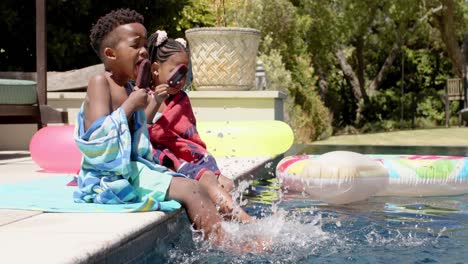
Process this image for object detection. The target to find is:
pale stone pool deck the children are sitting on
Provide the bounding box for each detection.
[0,151,271,263]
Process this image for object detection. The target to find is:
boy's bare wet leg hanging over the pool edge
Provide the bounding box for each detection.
[167,177,225,244]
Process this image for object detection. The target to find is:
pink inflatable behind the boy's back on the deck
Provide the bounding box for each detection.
[29,125,81,174]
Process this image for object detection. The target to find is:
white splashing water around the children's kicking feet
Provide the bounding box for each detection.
[168,207,333,263]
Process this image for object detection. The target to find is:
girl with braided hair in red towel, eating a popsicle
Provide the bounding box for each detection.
[146,30,250,223]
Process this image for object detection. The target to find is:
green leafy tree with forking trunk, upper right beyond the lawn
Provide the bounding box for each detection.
[298,0,448,125]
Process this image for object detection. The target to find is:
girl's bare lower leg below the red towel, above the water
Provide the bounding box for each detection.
[199,171,251,224]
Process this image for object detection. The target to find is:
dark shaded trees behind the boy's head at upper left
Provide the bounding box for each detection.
[0,0,188,71]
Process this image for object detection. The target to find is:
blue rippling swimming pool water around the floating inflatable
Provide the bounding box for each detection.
[146,146,468,263]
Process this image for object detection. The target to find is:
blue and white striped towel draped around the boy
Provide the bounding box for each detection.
[73,106,180,211]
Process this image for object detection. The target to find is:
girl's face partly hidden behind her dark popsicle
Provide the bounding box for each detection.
[158,51,189,95]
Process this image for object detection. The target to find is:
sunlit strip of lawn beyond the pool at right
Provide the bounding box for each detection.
[312,127,468,146]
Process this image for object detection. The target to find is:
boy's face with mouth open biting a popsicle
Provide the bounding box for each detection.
[104,23,148,80]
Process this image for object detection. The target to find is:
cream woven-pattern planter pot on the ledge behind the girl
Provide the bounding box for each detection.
[185,27,260,91]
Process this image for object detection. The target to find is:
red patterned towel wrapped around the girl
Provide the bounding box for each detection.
[148,91,207,171]
